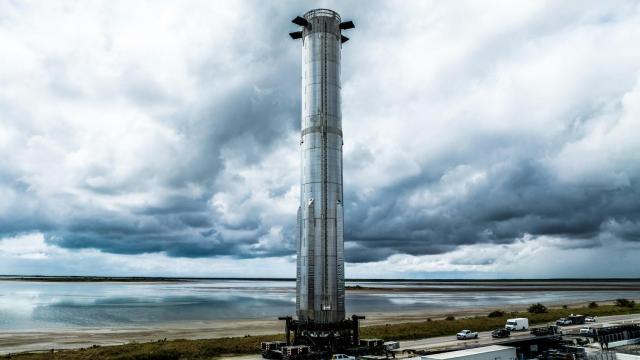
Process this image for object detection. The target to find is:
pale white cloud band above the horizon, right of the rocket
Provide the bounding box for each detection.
[348,235,640,278]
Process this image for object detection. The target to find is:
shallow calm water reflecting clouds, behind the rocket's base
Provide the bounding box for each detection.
[0,280,640,330]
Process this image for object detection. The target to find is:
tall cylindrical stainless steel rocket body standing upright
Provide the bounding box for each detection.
[296,9,345,323]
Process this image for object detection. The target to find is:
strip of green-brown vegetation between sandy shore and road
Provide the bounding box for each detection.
[6,302,640,360]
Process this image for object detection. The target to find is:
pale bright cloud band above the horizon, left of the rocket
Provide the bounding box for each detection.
[0,233,295,277]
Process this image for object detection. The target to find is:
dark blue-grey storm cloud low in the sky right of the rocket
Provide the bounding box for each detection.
[345,160,640,262]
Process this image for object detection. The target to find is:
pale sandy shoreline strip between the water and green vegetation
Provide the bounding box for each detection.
[0,301,636,355]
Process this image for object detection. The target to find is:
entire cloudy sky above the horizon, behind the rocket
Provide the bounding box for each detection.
[0,0,640,278]
